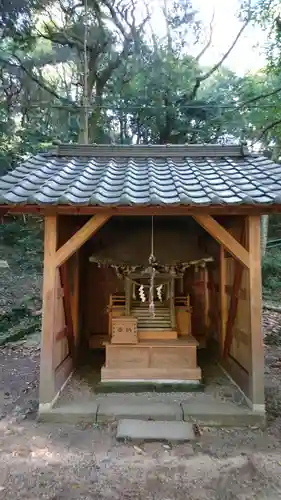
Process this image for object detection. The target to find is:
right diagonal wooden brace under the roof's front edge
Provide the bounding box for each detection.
[193,215,250,267]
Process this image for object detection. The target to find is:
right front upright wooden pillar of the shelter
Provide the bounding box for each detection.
[247,215,264,411]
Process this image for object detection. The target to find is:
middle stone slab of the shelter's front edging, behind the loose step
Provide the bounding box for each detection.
[97,397,183,422]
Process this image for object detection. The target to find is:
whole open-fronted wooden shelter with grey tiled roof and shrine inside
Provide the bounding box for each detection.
[0,144,274,412]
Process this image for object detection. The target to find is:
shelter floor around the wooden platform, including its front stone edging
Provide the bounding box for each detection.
[39,350,265,427]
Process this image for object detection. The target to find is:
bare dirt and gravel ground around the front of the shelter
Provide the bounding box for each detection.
[0,313,281,500]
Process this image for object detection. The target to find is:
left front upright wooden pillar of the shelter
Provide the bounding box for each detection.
[39,215,58,404]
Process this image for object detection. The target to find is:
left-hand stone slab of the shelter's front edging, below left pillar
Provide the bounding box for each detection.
[38,401,99,424]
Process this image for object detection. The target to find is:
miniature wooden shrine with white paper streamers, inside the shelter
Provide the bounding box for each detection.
[87,217,213,383]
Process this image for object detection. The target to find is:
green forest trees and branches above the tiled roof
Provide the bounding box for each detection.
[0,0,281,173]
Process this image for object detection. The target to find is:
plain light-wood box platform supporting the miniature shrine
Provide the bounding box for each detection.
[101,336,201,382]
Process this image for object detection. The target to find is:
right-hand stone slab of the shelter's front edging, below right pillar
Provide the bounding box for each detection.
[181,399,265,427]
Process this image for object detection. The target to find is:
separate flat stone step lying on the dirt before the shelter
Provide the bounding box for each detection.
[116,419,196,442]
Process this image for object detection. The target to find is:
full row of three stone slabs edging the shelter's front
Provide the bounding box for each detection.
[39,394,265,427]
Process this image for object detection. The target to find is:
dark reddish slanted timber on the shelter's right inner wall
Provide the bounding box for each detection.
[223,224,246,359]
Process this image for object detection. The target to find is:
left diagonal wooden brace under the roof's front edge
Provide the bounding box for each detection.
[55,214,110,267]
